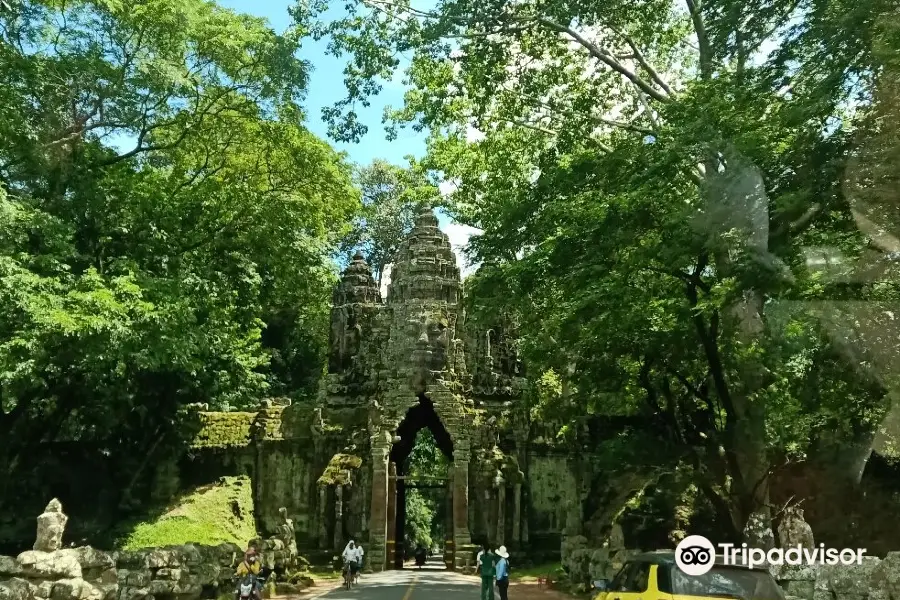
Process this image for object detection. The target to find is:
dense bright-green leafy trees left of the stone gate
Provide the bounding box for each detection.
[0,0,358,502]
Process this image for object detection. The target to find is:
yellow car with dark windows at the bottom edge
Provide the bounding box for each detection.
[594,551,785,600]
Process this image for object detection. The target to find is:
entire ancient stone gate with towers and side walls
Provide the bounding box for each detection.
[243,210,612,570]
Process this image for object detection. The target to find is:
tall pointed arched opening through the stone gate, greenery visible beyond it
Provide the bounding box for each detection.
[388,394,453,569]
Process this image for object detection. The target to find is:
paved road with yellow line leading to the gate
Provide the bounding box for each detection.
[321,557,479,600]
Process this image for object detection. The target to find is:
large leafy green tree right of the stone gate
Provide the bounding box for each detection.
[304,0,890,536]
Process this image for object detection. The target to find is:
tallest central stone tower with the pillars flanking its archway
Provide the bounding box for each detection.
[369,210,472,572]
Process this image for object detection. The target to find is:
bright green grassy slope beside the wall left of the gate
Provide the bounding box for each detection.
[122,477,256,550]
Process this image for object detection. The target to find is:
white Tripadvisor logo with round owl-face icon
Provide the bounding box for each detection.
[675,535,866,576]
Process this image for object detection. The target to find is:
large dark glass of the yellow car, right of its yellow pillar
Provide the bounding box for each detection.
[671,566,784,600]
